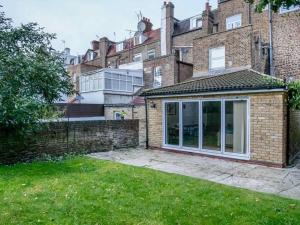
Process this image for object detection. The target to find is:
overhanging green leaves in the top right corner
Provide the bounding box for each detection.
[246,0,300,12]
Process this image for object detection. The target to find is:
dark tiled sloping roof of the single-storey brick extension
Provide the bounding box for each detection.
[141,69,285,96]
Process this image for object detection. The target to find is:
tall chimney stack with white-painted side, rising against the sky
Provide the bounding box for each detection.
[160,2,175,56]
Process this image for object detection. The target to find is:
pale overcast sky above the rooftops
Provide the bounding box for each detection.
[0,0,217,55]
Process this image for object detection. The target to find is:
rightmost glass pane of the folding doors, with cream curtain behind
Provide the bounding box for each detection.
[225,101,247,154]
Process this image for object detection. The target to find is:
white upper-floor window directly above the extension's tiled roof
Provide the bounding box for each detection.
[209,46,225,70]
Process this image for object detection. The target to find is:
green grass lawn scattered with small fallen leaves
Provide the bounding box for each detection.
[0,157,300,225]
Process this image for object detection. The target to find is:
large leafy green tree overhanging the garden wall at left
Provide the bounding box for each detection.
[0,6,73,134]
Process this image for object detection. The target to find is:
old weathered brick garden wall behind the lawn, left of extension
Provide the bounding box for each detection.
[0,120,139,164]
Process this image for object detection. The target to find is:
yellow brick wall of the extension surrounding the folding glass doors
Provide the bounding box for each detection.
[148,93,287,166]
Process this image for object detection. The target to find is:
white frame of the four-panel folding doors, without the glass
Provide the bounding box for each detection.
[162,97,251,160]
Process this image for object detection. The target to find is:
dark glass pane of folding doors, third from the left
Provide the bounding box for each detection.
[202,101,221,151]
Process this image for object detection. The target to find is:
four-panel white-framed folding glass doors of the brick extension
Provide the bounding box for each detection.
[163,99,249,159]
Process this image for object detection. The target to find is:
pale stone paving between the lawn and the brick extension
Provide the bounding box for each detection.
[90,149,300,200]
